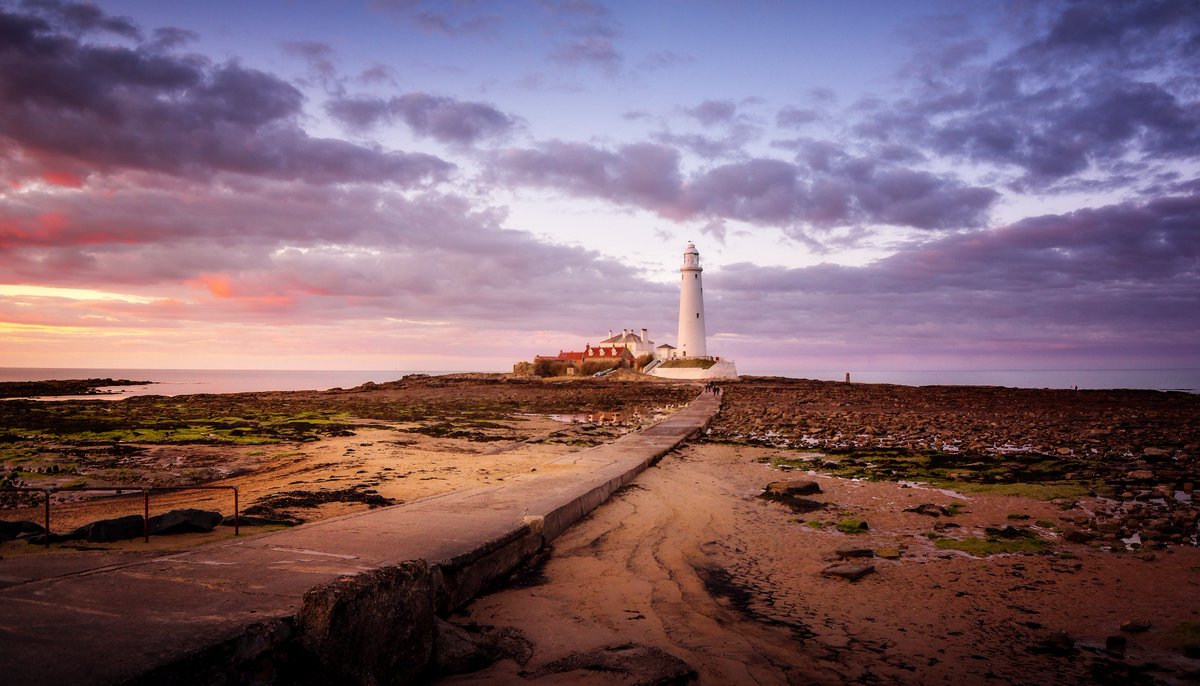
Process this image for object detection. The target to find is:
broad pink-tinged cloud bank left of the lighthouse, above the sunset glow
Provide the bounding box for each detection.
[0,167,671,333]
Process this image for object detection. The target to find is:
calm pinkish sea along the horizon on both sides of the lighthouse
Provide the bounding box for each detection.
[0,367,1200,399]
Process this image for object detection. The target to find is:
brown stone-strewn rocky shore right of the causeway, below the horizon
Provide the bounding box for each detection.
[709,378,1200,549]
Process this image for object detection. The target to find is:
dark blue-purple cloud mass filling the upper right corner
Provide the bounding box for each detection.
[856,0,1200,191]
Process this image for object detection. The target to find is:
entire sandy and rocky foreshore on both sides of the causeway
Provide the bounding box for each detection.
[0,374,1200,685]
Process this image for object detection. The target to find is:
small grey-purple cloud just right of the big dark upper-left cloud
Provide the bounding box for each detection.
[325,92,516,145]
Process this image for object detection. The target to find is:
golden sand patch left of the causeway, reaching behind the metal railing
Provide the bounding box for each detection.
[0,415,628,556]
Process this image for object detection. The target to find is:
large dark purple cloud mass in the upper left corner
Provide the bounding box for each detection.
[0,3,452,185]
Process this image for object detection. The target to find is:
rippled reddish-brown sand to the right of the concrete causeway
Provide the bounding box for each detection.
[444,444,1200,684]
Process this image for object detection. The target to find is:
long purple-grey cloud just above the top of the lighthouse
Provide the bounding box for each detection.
[497,142,998,229]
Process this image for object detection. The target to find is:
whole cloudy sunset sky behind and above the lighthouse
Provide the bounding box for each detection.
[0,0,1200,373]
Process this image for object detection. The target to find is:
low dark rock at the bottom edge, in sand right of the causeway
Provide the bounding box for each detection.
[521,643,696,686]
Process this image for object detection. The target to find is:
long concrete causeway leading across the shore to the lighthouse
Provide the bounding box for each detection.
[0,393,720,686]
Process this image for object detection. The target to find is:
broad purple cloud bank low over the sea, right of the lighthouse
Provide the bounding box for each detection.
[706,197,1200,368]
